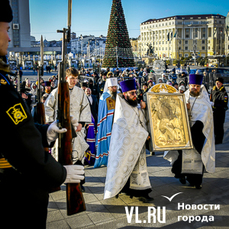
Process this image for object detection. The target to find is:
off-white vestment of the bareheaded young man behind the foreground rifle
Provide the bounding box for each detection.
[45,87,91,162]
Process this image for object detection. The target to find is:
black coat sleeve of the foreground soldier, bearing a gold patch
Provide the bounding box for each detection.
[0,72,66,186]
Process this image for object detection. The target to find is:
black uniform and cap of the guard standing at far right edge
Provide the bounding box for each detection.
[210,78,228,144]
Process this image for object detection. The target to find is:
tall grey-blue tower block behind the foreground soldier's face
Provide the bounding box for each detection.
[9,0,31,48]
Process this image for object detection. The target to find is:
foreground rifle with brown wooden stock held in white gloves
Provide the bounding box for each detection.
[57,0,86,215]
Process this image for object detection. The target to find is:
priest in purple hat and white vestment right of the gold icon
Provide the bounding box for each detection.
[164,74,215,189]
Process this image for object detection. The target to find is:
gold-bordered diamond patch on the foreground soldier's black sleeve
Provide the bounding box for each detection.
[6,103,27,125]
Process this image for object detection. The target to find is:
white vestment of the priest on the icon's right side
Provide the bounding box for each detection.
[164,85,215,173]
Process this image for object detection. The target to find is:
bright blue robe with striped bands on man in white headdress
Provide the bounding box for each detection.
[94,92,115,168]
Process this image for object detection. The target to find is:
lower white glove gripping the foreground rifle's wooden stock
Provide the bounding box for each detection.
[64,165,84,183]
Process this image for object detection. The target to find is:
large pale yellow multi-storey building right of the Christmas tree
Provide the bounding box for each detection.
[139,14,225,59]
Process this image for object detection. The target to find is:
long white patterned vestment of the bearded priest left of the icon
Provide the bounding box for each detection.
[104,96,151,199]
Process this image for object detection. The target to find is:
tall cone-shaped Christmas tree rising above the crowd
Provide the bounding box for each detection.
[103,0,135,68]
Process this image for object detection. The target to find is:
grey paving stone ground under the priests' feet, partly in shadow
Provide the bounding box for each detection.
[47,112,229,229]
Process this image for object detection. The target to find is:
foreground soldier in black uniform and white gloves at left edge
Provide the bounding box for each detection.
[0,0,83,229]
